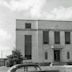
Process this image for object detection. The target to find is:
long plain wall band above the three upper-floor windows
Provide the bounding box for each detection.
[38,20,72,30]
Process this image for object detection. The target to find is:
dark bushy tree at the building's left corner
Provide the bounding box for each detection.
[6,49,24,67]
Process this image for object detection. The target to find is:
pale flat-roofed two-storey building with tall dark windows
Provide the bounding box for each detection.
[16,19,72,62]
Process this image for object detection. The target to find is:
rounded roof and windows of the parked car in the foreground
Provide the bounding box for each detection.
[7,63,41,72]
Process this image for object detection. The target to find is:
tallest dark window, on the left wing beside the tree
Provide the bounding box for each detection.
[25,35,32,59]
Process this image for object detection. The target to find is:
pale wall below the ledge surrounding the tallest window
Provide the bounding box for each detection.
[16,31,39,61]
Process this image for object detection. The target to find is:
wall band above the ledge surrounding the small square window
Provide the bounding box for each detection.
[16,20,38,29]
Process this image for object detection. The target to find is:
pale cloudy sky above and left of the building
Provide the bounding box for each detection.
[0,0,72,58]
